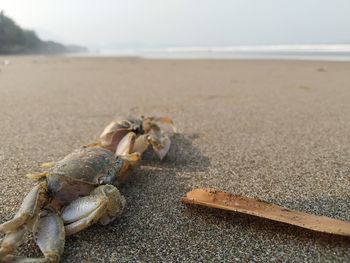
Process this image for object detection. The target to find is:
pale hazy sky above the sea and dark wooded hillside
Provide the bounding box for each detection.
[0,0,350,48]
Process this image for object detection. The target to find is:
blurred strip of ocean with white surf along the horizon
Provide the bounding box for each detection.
[78,44,350,61]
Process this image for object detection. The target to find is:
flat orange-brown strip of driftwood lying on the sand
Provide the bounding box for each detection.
[182,189,350,236]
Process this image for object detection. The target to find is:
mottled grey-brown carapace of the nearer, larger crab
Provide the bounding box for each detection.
[47,148,123,205]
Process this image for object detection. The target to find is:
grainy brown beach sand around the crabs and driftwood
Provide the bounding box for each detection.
[0,57,350,262]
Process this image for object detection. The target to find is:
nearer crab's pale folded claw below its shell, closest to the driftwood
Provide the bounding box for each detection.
[61,185,125,236]
